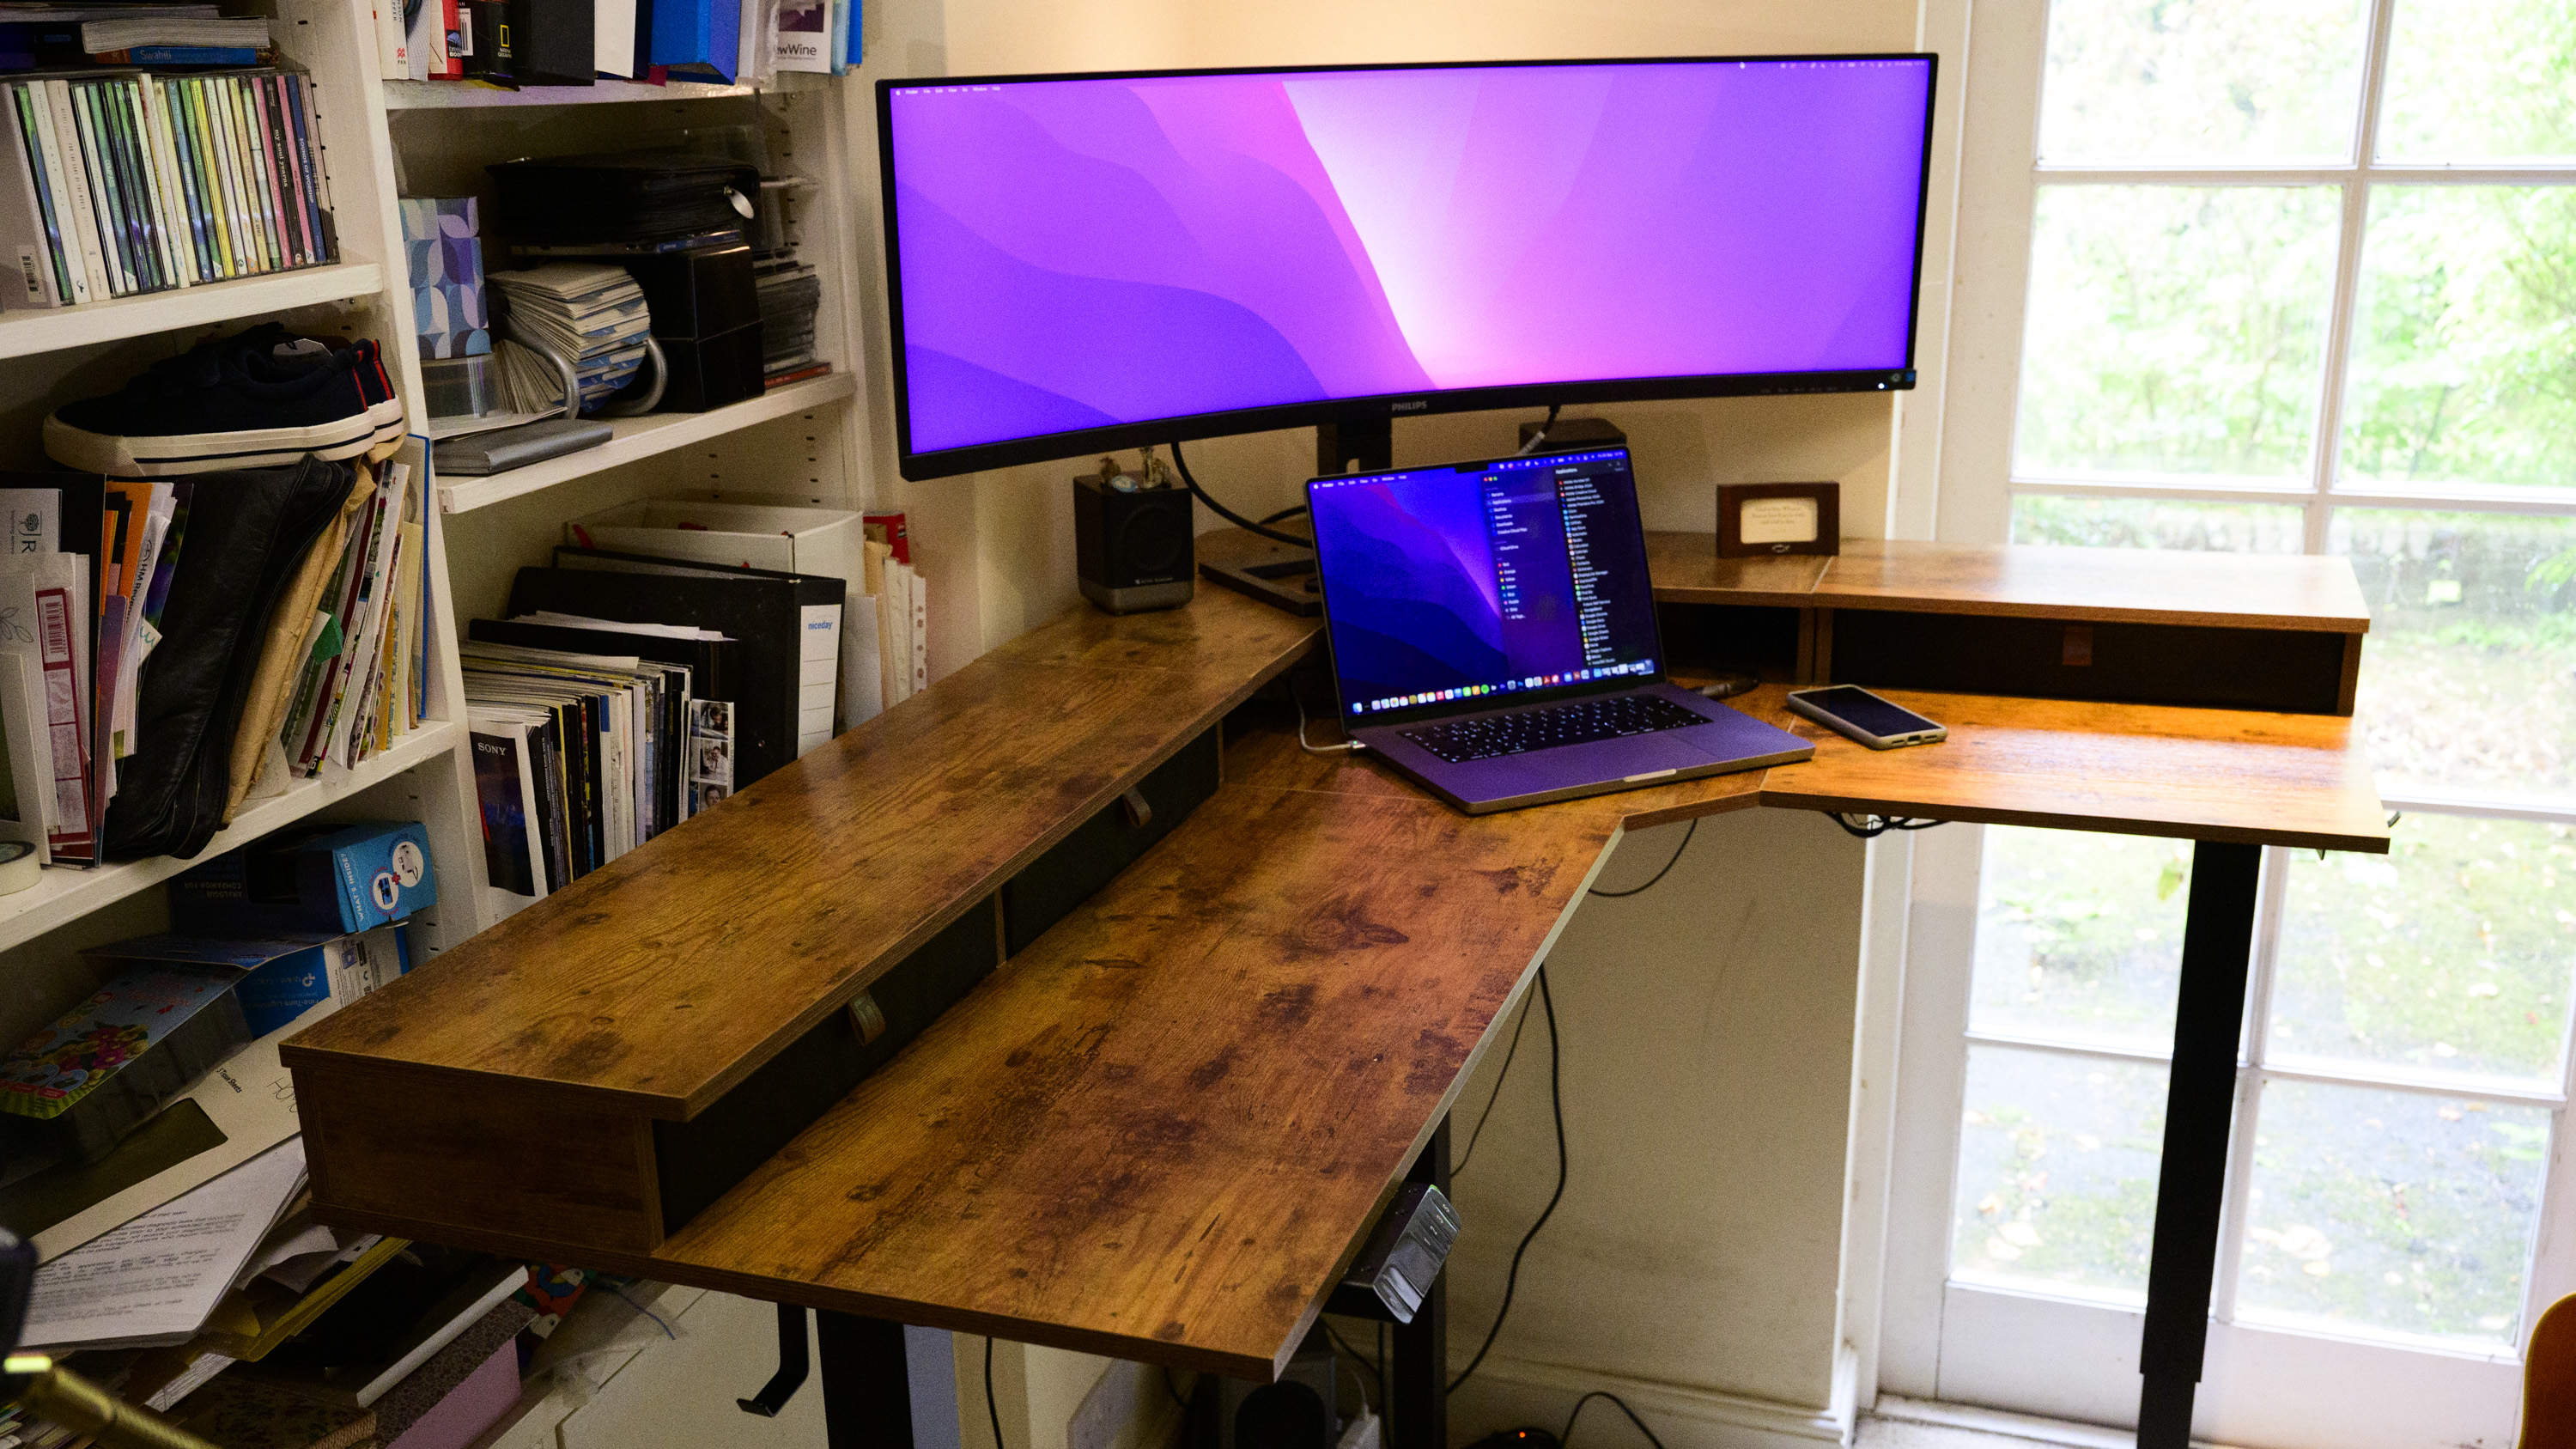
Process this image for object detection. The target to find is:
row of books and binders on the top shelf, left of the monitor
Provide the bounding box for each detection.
[376,0,860,90]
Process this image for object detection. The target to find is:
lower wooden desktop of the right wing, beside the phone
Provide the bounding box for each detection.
[1749,685,2388,854]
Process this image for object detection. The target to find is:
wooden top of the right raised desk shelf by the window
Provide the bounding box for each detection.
[1814,539,2370,634]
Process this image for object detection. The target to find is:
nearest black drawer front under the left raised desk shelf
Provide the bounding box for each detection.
[652,900,994,1233]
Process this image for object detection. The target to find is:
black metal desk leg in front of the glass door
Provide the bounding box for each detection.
[2138,841,2262,1449]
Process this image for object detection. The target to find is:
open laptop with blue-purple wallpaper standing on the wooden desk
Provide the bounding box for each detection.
[1306,448,1816,815]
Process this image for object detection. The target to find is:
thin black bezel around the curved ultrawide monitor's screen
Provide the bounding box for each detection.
[876,52,1940,482]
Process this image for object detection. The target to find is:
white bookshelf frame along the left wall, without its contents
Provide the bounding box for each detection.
[0,0,866,1034]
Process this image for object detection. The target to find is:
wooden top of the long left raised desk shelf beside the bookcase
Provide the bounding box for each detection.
[283,580,1314,1119]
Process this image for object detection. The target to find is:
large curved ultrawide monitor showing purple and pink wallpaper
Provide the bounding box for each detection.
[876,54,1932,477]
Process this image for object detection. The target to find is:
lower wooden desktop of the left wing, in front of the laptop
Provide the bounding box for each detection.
[657,784,1618,1377]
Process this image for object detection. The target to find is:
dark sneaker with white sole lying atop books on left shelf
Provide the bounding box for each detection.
[44,327,386,477]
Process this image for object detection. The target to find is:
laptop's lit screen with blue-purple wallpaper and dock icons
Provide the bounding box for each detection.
[1306,448,1656,721]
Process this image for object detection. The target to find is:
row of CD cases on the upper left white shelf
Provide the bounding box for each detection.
[0,70,337,307]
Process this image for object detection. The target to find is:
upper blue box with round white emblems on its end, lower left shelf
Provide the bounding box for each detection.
[170,820,438,936]
